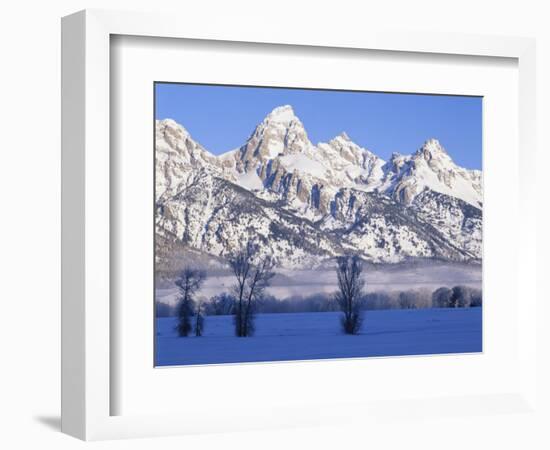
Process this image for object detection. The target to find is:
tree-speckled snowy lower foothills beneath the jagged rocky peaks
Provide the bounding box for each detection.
[156,170,473,267]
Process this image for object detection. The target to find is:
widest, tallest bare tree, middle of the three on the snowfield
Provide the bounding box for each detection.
[228,242,275,337]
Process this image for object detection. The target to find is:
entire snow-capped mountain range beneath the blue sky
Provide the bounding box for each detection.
[155,105,482,267]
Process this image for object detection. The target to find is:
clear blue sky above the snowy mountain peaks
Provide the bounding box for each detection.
[155,83,482,169]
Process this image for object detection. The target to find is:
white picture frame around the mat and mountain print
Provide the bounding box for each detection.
[62,10,540,440]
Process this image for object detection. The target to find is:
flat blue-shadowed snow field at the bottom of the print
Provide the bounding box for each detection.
[156,308,482,366]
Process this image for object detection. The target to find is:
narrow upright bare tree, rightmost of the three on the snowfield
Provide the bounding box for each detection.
[336,255,365,334]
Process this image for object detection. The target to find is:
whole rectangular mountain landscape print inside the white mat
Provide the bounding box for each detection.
[154,82,483,366]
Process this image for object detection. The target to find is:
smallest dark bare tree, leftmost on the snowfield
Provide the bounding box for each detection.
[175,267,206,337]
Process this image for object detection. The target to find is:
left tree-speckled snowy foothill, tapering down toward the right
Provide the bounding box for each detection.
[156,170,351,267]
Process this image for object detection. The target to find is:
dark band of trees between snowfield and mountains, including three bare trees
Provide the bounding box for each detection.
[167,243,482,337]
